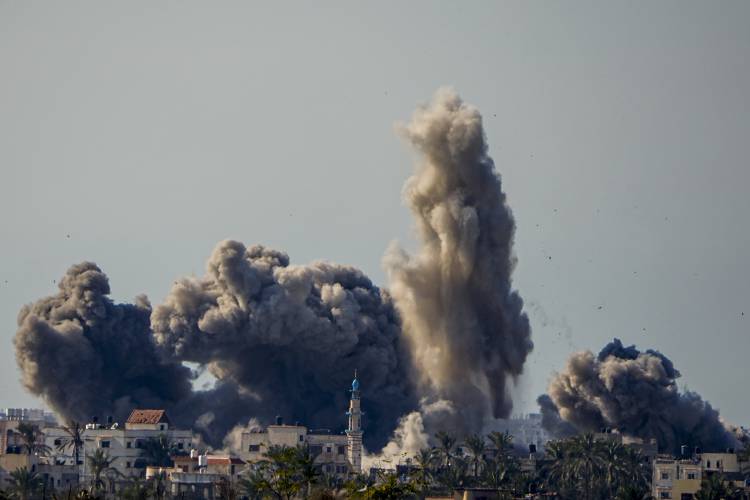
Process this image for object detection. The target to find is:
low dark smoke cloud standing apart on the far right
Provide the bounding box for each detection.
[538,339,736,452]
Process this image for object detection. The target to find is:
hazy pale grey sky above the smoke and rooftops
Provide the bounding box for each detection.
[0,1,750,425]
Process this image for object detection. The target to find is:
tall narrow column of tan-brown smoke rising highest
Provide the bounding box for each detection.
[385,90,532,431]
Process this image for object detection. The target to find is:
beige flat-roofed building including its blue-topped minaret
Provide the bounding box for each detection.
[240,374,363,477]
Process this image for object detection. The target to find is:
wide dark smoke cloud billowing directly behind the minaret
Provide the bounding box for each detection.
[151,241,417,445]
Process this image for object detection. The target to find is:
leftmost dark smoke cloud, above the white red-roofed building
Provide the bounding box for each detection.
[14,262,191,420]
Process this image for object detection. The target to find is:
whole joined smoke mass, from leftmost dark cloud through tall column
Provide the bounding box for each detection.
[15,90,532,450]
